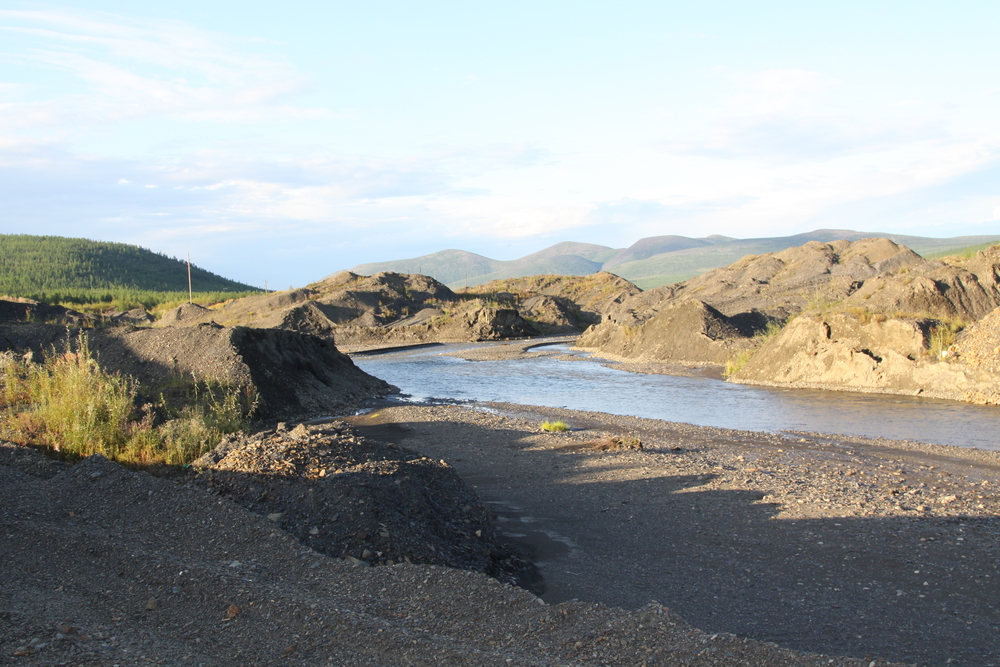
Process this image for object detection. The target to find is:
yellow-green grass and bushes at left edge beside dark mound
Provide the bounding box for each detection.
[0,334,256,465]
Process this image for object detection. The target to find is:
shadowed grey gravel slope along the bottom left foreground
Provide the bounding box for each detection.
[0,420,916,667]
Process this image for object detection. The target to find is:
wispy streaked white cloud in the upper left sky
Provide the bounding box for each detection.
[0,9,329,127]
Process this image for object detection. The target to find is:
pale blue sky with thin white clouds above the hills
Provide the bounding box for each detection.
[0,0,1000,288]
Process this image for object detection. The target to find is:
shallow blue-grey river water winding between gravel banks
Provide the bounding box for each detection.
[354,344,1000,450]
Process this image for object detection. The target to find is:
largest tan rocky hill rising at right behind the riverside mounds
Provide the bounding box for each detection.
[577,239,1000,378]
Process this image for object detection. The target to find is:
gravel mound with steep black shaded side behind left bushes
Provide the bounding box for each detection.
[0,324,393,419]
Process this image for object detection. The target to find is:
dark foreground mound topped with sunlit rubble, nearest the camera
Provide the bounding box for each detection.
[188,422,527,582]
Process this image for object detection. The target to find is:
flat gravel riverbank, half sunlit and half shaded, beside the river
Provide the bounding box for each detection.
[349,404,1000,666]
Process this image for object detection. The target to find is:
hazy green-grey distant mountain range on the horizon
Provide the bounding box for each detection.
[351,229,1000,289]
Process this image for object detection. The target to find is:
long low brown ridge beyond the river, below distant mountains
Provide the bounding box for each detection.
[158,271,639,349]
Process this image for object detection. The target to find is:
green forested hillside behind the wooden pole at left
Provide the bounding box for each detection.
[0,234,259,304]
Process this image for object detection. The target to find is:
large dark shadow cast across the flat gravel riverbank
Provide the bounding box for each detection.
[356,420,1000,666]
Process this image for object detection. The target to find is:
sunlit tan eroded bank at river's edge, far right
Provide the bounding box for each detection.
[730,311,1000,405]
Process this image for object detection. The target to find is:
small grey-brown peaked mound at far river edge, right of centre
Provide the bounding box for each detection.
[576,299,752,364]
